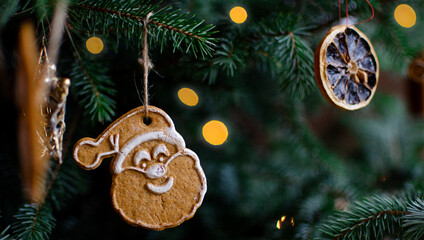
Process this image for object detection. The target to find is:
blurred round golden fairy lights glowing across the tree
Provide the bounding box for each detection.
[86,1,417,229]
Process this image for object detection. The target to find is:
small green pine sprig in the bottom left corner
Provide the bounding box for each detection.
[12,204,56,240]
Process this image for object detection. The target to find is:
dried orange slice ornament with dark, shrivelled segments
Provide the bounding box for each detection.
[315,25,379,110]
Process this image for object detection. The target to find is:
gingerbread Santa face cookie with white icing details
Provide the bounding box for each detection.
[74,106,206,230]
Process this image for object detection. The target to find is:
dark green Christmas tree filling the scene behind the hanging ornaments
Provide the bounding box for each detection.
[0,0,424,239]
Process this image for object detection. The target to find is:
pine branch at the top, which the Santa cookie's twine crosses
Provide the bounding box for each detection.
[69,0,216,57]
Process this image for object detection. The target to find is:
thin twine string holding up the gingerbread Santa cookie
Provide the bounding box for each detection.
[142,12,153,118]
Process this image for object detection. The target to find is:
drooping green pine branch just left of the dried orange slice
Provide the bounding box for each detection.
[196,15,315,94]
